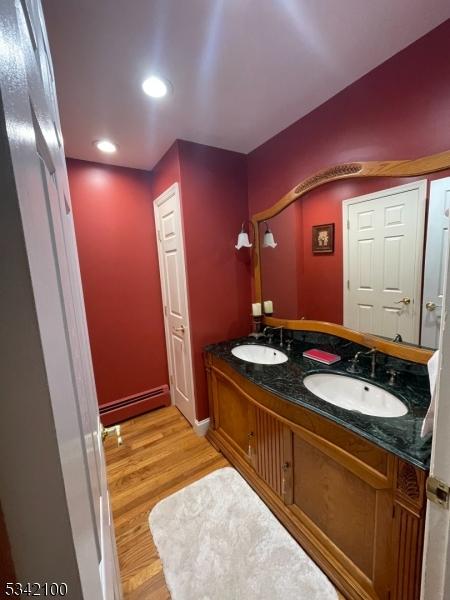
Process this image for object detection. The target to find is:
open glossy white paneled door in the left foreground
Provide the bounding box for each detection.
[0,0,121,600]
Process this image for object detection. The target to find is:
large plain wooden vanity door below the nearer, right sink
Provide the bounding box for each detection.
[291,432,393,600]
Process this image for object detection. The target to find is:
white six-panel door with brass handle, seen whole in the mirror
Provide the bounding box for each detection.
[343,180,426,343]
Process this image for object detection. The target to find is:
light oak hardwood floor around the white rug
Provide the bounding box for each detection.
[105,406,344,600]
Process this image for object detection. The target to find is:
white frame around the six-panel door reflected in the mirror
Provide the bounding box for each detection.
[342,179,428,340]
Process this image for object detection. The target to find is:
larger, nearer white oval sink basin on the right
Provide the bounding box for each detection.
[303,373,408,417]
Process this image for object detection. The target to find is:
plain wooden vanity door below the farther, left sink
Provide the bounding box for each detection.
[212,373,251,460]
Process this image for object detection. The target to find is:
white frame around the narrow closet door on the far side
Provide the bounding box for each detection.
[153,182,197,426]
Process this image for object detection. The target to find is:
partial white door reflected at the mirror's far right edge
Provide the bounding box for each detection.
[420,177,450,348]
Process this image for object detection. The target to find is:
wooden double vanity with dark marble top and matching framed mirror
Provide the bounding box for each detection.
[205,151,450,600]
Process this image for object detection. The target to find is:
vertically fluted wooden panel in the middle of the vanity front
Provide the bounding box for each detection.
[249,405,292,504]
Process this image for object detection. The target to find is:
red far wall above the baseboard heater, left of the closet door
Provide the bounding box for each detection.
[67,158,168,405]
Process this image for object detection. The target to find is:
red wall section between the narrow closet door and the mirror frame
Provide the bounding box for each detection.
[152,140,251,420]
